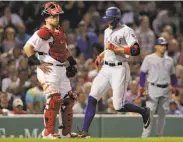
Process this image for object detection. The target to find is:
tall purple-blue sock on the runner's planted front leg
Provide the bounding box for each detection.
[82,96,97,132]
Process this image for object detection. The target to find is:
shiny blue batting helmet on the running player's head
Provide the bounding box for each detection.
[103,7,121,28]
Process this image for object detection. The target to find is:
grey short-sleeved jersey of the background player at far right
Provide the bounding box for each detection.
[140,53,175,84]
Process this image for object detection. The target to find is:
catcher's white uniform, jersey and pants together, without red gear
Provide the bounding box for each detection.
[27,31,71,96]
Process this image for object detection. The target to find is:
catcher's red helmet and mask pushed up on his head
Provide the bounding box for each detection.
[41,2,64,16]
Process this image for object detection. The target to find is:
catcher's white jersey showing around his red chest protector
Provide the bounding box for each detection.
[27,31,63,64]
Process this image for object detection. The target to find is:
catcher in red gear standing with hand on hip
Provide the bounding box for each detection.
[24,2,77,139]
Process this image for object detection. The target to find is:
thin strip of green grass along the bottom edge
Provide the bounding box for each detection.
[0,137,183,142]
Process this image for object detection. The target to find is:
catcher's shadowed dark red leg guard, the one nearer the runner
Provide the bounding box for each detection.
[62,91,75,136]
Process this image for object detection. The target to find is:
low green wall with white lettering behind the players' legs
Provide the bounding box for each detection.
[0,115,183,137]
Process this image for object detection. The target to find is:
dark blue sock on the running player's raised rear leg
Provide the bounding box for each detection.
[117,102,145,114]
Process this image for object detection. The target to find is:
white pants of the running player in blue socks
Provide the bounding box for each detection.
[90,62,130,110]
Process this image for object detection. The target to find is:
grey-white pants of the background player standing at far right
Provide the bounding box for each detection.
[142,84,170,138]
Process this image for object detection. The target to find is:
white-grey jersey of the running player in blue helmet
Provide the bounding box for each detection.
[104,25,138,63]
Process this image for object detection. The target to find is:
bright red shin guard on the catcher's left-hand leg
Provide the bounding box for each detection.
[43,93,61,136]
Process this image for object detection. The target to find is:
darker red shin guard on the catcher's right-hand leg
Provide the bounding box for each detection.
[59,92,76,137]
